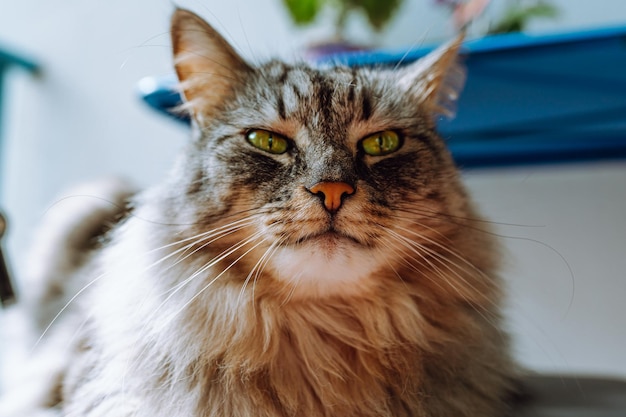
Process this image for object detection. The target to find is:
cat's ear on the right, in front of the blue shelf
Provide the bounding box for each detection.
[400,35,465,117]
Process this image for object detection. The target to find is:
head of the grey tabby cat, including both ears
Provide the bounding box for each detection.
[166,11,467,296]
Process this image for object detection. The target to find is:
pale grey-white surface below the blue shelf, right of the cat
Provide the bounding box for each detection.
[466,162,626,377]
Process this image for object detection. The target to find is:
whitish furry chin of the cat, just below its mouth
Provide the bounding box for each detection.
[270,232,381,299]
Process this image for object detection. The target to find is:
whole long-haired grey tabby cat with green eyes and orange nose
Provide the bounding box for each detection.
[0,9,518,417]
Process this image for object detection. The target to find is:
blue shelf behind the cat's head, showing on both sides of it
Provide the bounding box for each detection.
[143,26,626,167]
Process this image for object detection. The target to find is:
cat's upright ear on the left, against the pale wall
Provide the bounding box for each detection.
[171,9,251,124]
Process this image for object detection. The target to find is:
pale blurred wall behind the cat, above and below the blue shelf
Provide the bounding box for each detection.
[0,0,626,377]
